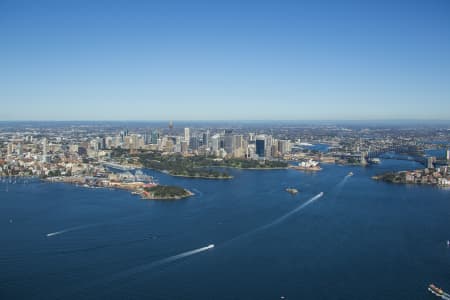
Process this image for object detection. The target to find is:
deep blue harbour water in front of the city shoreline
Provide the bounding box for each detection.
[0,160,450,299]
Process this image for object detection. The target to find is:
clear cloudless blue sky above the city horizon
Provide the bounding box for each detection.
[0,0,450,120]
